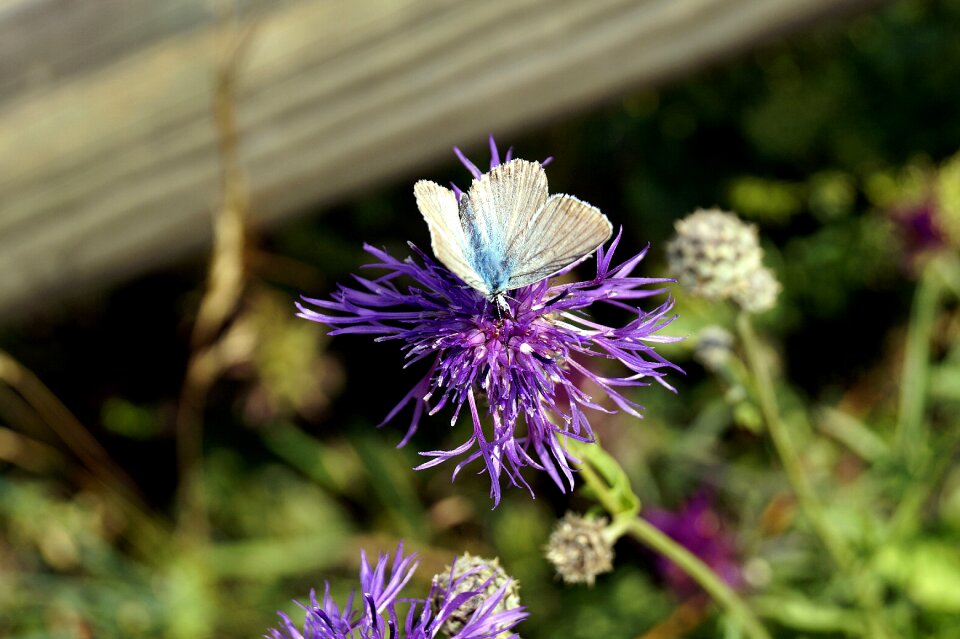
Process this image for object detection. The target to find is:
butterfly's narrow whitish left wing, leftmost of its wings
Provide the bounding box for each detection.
[413,180,489,295]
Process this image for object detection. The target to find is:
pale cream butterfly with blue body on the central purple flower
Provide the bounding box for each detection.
[413,159,613,307]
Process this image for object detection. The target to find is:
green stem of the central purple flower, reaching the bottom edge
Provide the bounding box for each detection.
[580,460,770,639]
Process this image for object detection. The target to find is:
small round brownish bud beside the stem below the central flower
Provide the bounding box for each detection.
[544,512,613,586]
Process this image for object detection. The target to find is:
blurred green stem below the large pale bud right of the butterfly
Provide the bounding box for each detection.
[737,312,888,639]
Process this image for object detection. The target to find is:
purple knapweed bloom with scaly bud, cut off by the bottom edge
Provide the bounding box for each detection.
[264,544,527,639]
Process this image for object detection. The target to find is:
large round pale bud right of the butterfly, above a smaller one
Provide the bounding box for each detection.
[667,209,763,300]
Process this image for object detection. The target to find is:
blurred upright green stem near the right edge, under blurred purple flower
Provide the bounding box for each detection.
[896,259,943,471]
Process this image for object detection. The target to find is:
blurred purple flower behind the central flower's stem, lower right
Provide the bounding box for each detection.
[646,491,743,597]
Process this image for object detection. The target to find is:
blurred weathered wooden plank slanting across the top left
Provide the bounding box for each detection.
[0,0,872,321]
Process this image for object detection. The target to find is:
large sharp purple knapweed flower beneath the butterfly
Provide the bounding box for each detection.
[297,137,679,504]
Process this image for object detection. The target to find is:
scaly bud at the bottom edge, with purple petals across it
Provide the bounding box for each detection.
[430,553,520,637]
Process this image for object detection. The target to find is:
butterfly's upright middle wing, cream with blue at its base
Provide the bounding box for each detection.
[460,159,547,294]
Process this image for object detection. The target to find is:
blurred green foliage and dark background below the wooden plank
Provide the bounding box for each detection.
[0,0,960,639]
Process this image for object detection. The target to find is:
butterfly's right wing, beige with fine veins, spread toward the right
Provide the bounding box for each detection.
[509,193,613,289]
